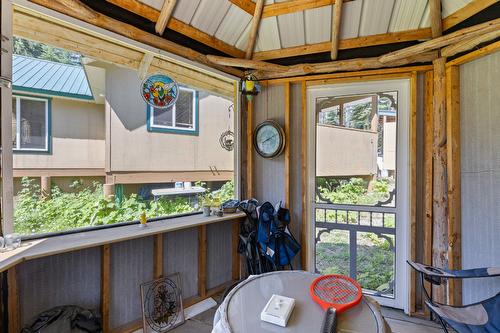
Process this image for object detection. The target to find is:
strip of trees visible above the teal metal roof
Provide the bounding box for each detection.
[13,37,80,65]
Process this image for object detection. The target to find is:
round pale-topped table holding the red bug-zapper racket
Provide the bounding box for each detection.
[212,271,390,333]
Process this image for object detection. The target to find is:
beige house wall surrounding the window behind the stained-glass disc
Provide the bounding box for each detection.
[106,66,234,173]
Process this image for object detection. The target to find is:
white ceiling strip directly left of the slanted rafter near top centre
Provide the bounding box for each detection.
[215,6,252,45]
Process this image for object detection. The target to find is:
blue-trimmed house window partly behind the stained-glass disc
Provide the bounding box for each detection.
[148,87,198,135]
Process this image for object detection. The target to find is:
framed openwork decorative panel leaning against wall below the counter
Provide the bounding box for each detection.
[141,273,185,333]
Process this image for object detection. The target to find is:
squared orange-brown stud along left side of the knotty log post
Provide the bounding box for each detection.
[421,71,434,315]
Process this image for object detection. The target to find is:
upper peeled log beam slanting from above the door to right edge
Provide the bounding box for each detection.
[379,18,500,63]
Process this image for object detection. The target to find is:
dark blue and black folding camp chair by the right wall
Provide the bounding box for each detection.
[408,261,500,333]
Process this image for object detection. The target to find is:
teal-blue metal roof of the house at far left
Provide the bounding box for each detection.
[12,54,94,100]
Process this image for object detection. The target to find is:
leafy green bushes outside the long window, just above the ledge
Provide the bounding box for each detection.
[14,177,238,235]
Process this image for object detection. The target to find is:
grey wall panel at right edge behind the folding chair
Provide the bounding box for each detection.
[460,52,500,304]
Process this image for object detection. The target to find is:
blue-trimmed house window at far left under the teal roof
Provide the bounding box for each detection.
[12,96,50,152]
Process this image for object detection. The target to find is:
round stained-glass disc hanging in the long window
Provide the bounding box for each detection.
[141,74,179,109]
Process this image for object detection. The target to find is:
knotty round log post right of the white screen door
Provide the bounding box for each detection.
[432,58,448,303]
